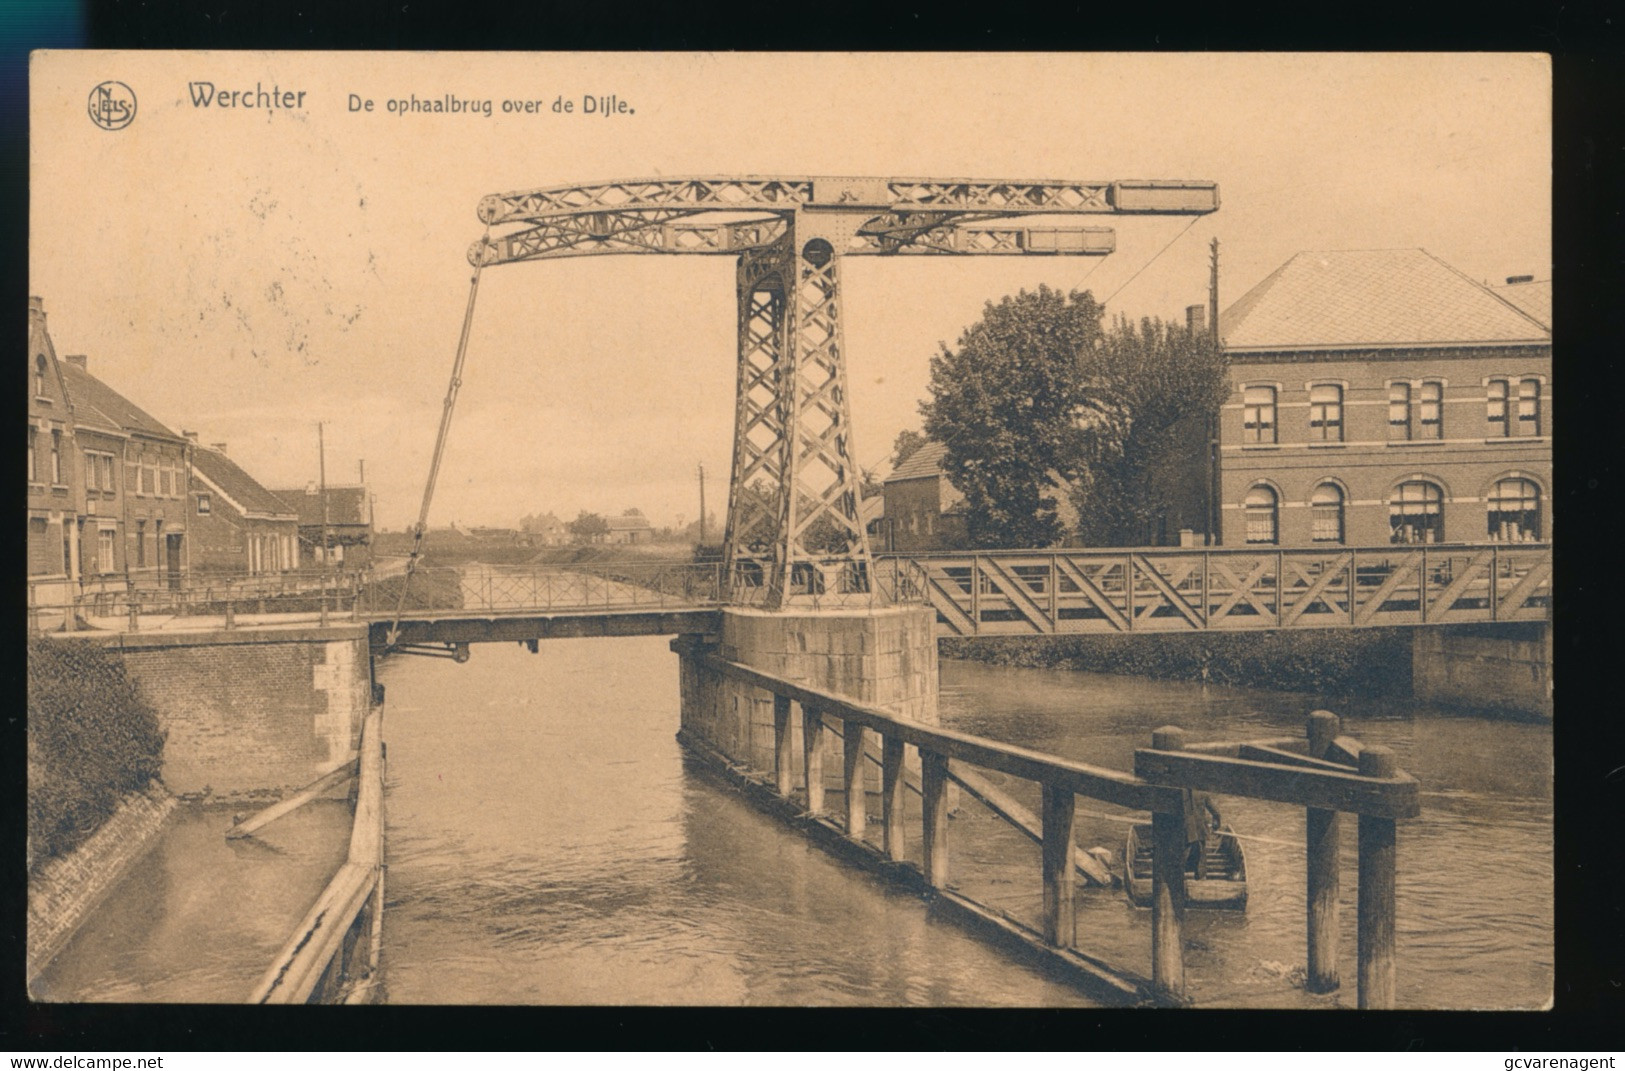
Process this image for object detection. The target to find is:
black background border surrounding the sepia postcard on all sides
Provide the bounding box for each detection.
[0,0,1625,1053]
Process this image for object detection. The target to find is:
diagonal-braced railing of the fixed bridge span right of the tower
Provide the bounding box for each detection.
[881,543,1552,635]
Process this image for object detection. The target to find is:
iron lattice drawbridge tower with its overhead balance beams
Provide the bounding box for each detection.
[465,177,1219,609]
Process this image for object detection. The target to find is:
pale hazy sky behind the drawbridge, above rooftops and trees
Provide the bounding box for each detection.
[29,52,1552,528]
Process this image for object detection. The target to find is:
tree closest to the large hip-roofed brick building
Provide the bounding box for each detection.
[1073,317,1227,546]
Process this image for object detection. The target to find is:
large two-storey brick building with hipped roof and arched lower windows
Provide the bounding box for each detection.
[1219,249,1552,546]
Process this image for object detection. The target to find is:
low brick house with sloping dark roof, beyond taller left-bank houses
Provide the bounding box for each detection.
[187,445,299,575]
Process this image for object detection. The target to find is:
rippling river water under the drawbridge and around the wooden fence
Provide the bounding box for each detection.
[380,639,1552,1008]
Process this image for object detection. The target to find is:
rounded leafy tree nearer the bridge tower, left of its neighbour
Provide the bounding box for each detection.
[920,284,1103,546]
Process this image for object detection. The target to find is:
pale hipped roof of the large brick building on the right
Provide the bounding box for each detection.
[1219,249,1552,351]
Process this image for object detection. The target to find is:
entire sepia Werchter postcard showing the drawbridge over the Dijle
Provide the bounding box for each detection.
[26,50,1547,1014]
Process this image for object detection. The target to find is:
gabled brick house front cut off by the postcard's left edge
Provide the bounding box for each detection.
[28,297,85,603]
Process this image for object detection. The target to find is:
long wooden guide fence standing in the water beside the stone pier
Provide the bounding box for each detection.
[674,640,1419,1008]
